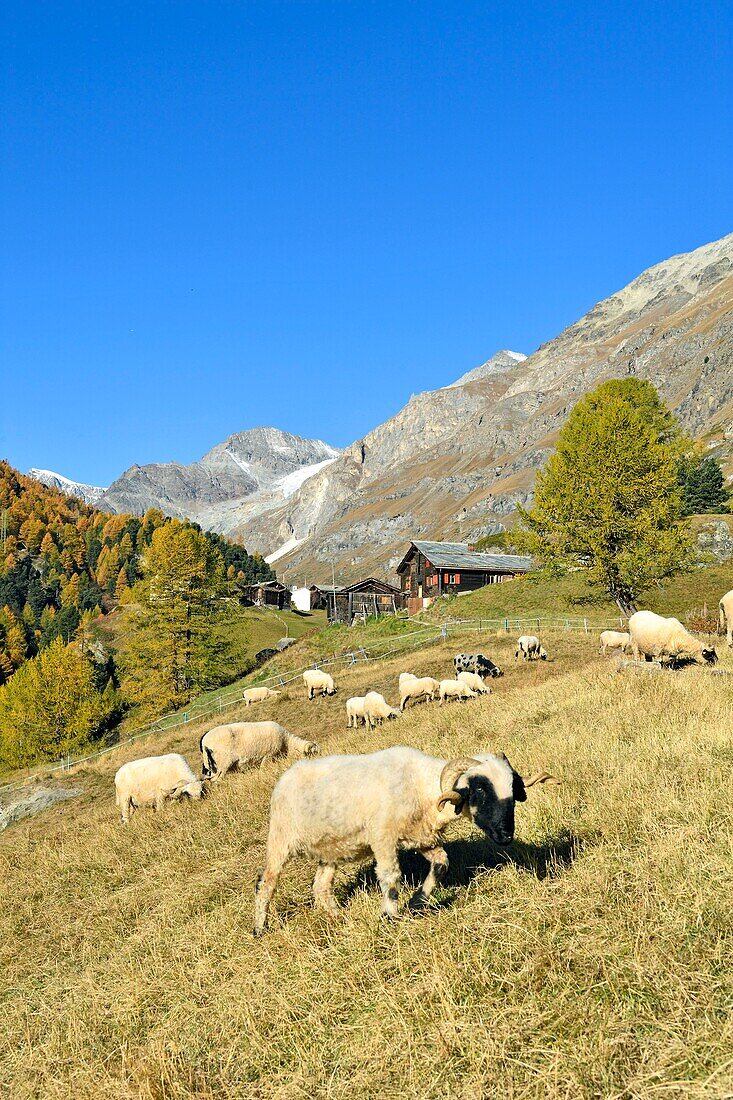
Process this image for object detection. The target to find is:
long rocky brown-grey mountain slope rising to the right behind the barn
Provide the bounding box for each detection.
[236,234,733,581]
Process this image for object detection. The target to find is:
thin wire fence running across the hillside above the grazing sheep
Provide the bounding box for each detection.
[0,616,624,791]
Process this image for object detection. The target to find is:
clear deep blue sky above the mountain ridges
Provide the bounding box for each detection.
[0,0,733,484]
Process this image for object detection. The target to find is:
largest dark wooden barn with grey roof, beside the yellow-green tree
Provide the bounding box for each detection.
[397,541,532,614]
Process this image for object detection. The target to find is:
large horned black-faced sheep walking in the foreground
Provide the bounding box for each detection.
[253,746,559,936]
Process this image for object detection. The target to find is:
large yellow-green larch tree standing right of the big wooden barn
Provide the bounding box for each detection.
[518,378,693,614]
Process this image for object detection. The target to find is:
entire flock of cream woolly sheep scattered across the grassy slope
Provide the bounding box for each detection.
[114,607,721,935]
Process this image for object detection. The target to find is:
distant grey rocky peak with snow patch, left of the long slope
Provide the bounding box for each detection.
[99,428,339,534]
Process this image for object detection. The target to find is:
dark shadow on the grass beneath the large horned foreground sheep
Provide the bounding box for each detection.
[336,833,582,909]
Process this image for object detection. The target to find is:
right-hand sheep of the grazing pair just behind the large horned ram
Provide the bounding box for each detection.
[198,722,320,782]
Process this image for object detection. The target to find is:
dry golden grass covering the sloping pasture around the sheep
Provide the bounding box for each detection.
[0,634,733,1100]
